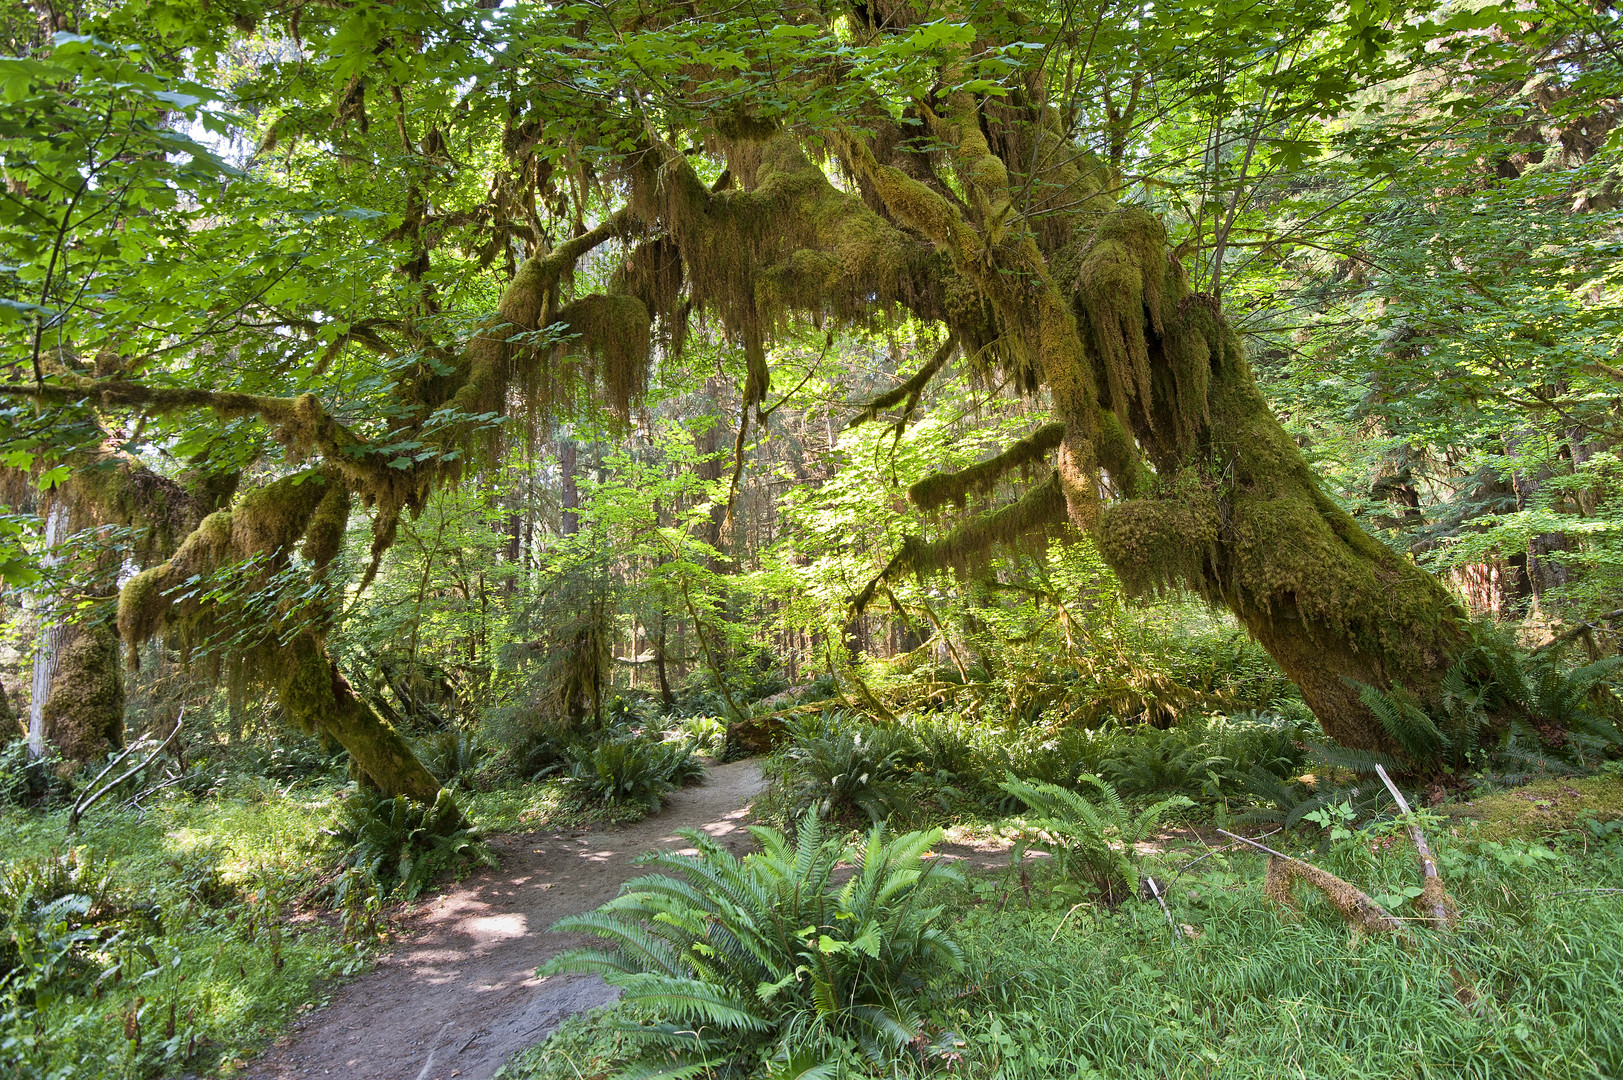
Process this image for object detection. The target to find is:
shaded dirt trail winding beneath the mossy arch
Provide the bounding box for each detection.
[248,762,761,1080]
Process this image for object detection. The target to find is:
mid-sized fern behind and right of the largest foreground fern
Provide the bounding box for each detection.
[1001,773,1195,906]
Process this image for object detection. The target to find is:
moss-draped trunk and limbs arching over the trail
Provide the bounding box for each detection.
[6,14,1461,776]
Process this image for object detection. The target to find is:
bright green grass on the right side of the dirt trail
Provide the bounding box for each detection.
[506,780,1623,1080]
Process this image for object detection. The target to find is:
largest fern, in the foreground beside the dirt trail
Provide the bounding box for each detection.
[542,814,959,1077]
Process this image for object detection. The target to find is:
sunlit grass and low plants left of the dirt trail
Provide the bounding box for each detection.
[0,776,636,1080]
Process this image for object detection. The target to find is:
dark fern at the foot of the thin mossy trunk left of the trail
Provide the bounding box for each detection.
[334,789,495,900]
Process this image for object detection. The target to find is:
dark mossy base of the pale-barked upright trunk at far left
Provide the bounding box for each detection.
[41,625,123,763]
